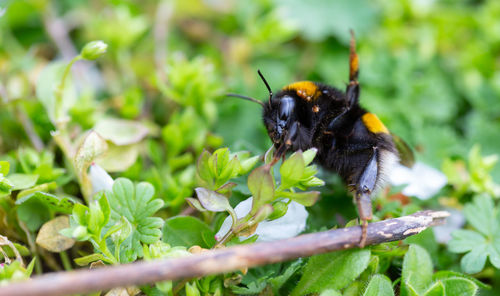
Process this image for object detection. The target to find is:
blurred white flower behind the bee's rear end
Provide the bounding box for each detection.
[389,162,448,200]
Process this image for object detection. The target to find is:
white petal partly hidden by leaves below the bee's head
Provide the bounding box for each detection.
[215,197,309,241]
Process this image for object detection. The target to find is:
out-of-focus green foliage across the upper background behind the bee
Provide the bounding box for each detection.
[0,0,500,177]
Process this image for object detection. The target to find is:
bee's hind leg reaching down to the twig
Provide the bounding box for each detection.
[356,147,378,248]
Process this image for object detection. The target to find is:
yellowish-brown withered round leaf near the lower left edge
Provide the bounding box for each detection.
[36,216,75,253]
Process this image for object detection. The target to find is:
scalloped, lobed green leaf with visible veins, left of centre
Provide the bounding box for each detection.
[106,178,163,261]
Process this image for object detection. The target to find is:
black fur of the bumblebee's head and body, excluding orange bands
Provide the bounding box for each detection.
[263,83,397,191]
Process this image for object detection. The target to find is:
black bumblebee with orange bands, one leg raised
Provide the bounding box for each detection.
[228,32,413,247]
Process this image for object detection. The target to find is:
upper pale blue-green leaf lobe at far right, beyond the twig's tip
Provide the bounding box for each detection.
[464,194,498,236]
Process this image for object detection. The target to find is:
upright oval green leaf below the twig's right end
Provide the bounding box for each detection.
[401,245,433,293]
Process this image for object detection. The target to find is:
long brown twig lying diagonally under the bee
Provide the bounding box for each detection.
[0,211,449,296]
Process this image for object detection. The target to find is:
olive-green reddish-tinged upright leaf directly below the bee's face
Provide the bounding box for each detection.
[247,166,274,213]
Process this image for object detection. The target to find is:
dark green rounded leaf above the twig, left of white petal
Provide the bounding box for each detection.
[163,216,215,248]
